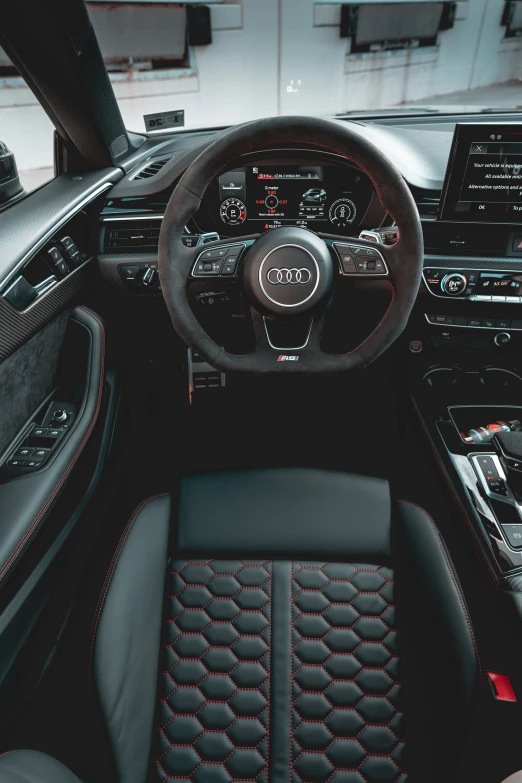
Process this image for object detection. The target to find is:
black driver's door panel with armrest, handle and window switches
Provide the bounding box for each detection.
[0,170,122,714]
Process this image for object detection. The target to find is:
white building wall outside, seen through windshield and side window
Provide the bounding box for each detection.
[0,0,522,181]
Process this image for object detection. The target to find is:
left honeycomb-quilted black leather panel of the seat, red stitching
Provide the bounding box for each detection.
[156,560,272,783]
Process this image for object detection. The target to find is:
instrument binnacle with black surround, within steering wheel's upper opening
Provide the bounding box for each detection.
[195,150,385,236]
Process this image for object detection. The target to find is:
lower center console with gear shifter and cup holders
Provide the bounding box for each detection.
[410,355,522,575]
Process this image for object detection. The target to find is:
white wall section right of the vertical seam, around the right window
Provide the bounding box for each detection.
[281,0,522,114]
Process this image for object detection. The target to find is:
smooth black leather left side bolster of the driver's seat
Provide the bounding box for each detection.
[92,495,171,783]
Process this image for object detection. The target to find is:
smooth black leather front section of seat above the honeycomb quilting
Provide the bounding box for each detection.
[177,468,391,558]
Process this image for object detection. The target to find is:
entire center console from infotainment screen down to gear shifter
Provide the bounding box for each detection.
[410,123,522,579]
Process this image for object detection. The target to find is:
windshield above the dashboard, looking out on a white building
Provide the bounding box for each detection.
[89,0,522,131]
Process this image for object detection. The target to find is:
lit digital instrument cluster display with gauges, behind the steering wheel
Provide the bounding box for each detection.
[211,163,373,234]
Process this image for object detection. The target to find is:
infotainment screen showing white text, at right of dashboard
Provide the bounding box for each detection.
[439,123,522,223]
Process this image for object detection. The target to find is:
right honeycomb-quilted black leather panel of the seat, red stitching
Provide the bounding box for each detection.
[291,563,405,782]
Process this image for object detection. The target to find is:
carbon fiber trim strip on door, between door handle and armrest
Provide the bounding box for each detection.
[0,261,96,361]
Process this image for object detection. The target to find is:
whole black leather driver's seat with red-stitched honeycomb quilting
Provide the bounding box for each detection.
[0,469,481,783]
